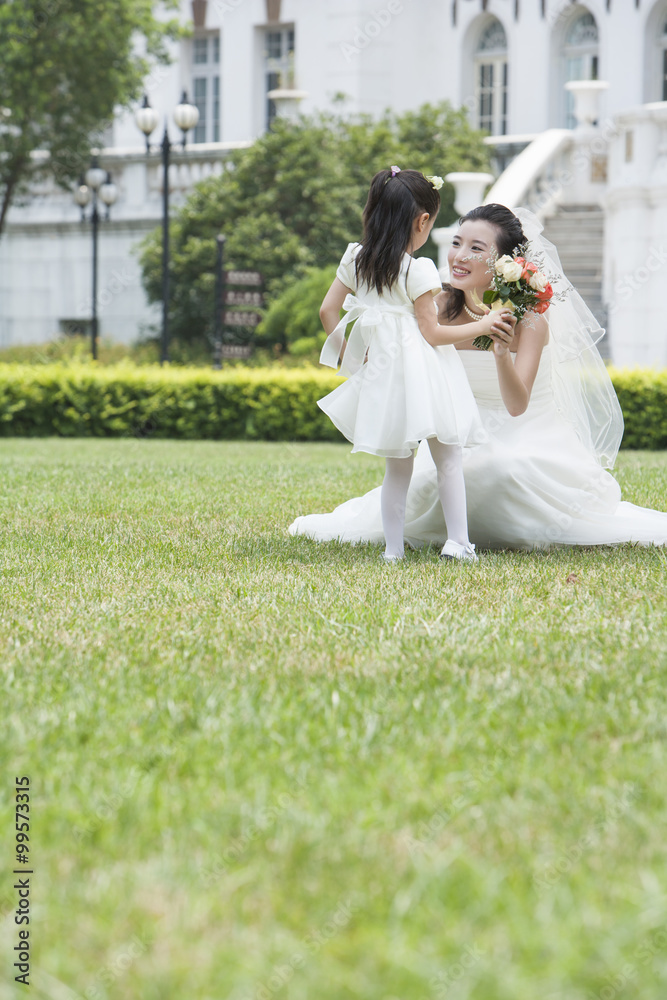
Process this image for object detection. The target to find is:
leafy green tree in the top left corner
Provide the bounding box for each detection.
[0,0,181,233]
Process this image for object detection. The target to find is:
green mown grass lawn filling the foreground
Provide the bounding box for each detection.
[0,440,667,1000]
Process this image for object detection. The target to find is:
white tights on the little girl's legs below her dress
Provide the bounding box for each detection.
[380,438,470,556]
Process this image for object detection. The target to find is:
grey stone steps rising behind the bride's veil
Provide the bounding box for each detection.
[544,205,609,360]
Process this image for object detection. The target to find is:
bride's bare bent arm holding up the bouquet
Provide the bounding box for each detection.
[490,313,549,417]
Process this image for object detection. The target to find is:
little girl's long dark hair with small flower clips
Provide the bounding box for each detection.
[355,169,440,295]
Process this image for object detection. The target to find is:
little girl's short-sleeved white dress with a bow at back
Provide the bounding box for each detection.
[318,243,486,458]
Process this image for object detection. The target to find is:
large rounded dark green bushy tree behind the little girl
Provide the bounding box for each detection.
[139,102,489,354]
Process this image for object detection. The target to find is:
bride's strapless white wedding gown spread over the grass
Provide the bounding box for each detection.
[289,345,667,549]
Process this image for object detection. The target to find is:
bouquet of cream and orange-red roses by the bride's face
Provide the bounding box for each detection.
[472,247,554,351]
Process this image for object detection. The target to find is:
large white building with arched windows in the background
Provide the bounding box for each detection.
[0,0,667,366]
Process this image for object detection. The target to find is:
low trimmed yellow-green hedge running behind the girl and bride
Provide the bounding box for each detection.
[0,364,667,450]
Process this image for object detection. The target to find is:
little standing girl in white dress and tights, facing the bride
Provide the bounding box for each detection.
[318,167,514,562]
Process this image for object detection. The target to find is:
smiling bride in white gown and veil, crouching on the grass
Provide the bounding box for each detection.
[289,204,667,549]
